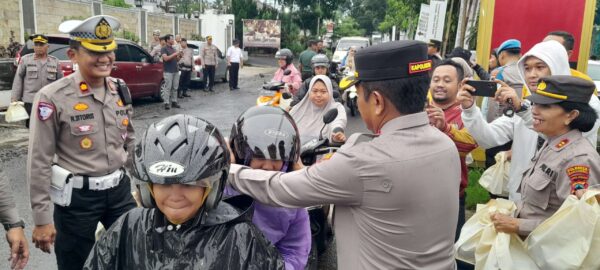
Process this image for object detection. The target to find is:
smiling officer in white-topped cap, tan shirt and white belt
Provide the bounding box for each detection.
[27,15,135,269]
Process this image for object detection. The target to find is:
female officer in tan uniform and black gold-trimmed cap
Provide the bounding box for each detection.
[492,75,600,237]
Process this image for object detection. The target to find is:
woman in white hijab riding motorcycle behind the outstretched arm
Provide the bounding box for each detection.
[290,75,347,144]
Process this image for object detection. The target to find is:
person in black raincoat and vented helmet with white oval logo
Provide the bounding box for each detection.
[84,114,284,269]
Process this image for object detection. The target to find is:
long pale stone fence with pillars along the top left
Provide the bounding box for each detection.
[0,0,201,46]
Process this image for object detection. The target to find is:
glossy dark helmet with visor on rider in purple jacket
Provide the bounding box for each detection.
[229,106,300,172]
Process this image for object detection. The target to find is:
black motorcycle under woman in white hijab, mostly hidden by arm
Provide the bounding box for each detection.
[300,109,342,269]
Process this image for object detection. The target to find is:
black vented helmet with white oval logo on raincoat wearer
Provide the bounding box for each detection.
[132,114,230,210]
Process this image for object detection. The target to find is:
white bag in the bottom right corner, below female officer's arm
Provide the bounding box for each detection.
[525,190,600,270]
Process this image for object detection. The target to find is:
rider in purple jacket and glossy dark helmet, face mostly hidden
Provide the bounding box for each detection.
[225,106,311,270]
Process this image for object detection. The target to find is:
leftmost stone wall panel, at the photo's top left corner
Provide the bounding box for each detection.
[0,0,23,46]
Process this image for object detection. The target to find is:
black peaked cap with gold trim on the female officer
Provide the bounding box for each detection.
[527,75,596,104]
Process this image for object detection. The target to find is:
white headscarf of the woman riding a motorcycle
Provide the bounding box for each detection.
[290,75,346,143]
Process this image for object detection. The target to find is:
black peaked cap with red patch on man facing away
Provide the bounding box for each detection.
[340,40,432,90]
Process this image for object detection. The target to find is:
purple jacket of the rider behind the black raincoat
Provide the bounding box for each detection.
[223,186,312,270]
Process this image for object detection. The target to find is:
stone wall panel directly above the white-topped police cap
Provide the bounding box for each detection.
[35,0,92,34]
